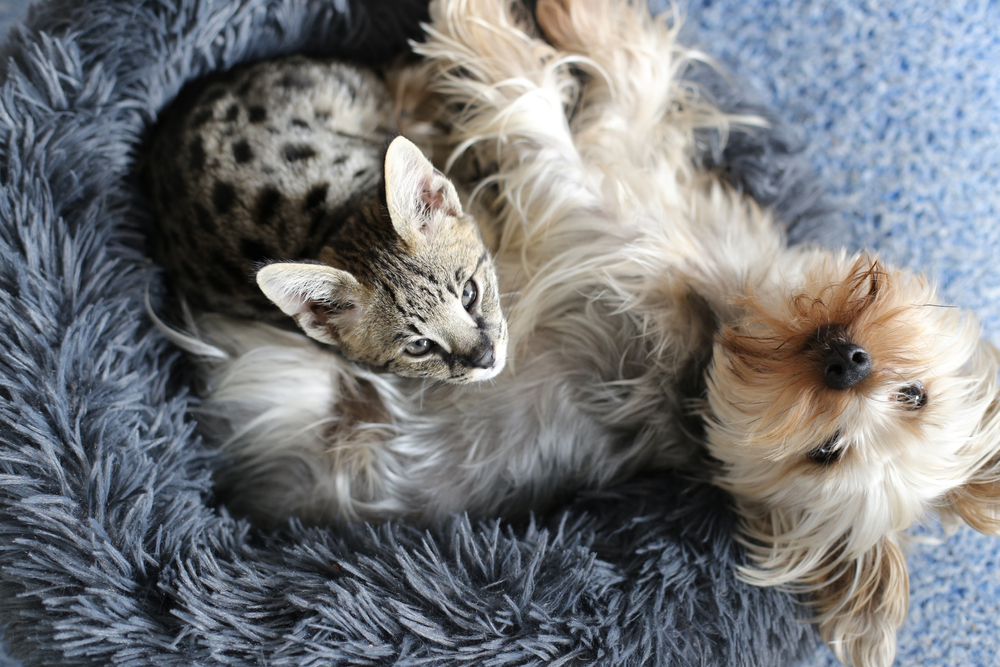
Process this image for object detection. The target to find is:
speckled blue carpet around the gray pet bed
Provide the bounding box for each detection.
[0,0,1000,667]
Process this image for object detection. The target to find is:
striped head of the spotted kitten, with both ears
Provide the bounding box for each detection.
[257,137,507,383]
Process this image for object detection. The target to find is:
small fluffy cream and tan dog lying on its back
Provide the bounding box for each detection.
[186,0,1000,667]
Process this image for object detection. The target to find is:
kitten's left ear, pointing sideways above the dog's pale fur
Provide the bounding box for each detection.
[257,262,364,345]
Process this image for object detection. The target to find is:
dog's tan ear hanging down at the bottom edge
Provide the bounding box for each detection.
[810,535,910,667]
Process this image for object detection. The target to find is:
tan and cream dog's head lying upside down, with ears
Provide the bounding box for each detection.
[708,251,1000,667]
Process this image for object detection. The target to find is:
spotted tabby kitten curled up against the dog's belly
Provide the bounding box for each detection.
[144,56,507,383]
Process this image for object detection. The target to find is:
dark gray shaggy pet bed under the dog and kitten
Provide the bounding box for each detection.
[0,0,823,666]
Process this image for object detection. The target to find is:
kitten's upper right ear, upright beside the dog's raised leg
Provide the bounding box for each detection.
[385,136,462,243]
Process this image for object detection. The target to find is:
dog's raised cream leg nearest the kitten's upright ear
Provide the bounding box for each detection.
[415,0,605,268]
